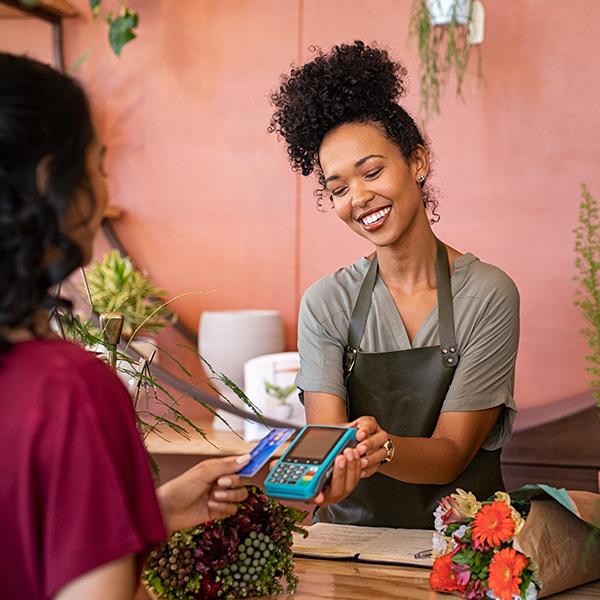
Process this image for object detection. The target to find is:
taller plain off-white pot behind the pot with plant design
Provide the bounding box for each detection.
[198,310,284,431]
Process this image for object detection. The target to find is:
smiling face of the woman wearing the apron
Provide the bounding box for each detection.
[319,123,429,246]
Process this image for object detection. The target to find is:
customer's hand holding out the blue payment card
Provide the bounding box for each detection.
[156,454,250,533]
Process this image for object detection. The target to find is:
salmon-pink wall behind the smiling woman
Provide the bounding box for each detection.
[50,0,600,408]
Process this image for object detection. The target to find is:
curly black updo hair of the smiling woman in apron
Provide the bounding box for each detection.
[268,41,438,216]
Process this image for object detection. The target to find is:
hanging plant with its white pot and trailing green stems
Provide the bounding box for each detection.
[410,0,483,117]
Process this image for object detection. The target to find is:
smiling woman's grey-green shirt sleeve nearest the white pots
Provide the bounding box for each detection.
[296,287,348,400]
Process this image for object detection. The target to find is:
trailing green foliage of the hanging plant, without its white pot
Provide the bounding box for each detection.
[409,0,482,117]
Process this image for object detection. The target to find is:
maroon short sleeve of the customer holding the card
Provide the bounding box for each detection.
[39,359,166,598]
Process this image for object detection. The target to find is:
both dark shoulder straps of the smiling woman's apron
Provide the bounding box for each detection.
[347,238,459,368]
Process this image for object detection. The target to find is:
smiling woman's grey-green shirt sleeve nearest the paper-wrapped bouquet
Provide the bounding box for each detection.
[442,275,519,450]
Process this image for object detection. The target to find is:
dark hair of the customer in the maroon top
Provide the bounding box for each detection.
[0,53,94,351]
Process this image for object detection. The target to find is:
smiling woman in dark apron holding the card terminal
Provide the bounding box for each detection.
[270,42,519,527]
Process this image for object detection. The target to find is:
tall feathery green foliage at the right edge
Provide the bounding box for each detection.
[574,183,600,406]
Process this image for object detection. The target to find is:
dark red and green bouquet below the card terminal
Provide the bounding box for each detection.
[144,486,306,600]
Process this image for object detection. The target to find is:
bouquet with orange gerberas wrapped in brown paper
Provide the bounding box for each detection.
[429,485,600,600]
